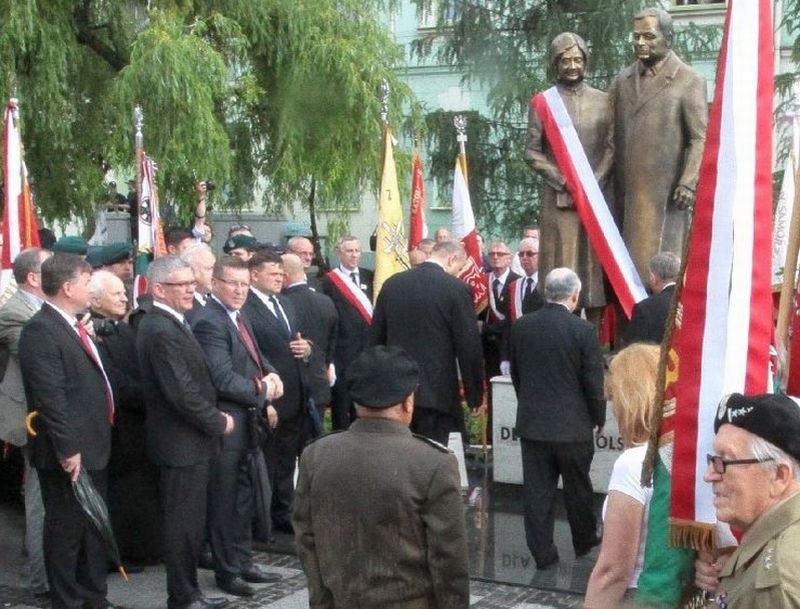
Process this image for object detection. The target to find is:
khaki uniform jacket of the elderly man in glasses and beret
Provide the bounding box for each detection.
[717,493,800,609]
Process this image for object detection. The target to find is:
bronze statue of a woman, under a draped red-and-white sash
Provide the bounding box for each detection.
[525,32,612,322]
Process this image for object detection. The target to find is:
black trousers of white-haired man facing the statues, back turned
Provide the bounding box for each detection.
[520,438,597,563]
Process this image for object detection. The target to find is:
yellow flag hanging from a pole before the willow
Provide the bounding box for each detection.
[373,125,409,300]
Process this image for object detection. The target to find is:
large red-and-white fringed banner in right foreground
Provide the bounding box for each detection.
[661,0,774,547]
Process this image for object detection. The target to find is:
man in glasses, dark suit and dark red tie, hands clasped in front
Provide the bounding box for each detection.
[192,256,283,596]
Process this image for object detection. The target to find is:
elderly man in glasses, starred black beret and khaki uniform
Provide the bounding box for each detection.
[695,393,800,609]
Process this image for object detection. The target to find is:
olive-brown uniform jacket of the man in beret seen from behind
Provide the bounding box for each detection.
[293,418,469,609]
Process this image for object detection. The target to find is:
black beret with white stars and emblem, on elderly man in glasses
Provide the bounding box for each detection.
[714,393,800,461]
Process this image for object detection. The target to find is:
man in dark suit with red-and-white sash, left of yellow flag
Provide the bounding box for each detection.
[322,235,373,429]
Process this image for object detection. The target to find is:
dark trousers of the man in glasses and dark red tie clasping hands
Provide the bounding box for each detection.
[208,450,255,580]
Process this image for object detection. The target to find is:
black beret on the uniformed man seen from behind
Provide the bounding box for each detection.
[345,347,419,408]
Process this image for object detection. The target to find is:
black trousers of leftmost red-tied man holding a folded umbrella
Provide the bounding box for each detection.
[37,469,108,609]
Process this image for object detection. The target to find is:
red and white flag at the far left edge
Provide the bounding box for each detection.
[0,99,39,293]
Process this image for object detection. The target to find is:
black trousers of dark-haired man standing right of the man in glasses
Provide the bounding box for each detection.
[265,413,308,528]
